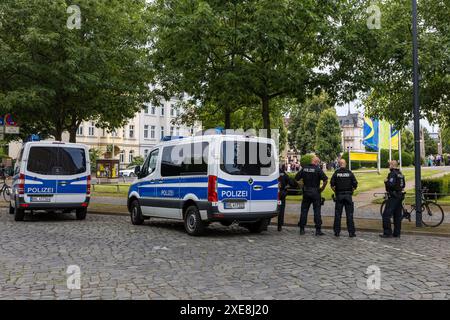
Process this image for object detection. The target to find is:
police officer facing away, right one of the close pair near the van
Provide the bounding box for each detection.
[330,159,358,238]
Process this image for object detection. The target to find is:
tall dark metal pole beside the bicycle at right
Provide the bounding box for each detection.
[412,0,422,227]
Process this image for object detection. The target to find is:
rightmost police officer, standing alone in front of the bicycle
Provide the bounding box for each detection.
[380,160,405,238]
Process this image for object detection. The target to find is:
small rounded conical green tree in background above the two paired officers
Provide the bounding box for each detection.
[315,108,341,163]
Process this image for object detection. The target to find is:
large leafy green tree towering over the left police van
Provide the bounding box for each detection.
[0,0,151,141]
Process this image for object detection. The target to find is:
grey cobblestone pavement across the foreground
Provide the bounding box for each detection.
[0,209,450,299]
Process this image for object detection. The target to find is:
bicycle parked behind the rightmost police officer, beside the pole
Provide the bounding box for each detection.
[380,189,444,228]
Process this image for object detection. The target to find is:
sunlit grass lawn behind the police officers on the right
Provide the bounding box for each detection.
[287,169,441,201]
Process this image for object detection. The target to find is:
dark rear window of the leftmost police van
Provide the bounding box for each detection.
[27,147,86,175]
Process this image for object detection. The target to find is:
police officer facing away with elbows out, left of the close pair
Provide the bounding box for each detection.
[295,156,328,236]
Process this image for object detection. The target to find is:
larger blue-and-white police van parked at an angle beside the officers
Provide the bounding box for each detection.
[128,134,279,235]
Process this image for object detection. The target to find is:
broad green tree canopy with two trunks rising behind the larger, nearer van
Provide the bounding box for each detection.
[151,0,337,135]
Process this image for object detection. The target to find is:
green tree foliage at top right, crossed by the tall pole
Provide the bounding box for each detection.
[330,0,450,127]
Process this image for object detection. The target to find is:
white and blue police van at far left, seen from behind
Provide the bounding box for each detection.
[9,142,91,221]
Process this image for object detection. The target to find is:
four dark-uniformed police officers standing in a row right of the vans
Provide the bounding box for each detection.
[278,157,405,238]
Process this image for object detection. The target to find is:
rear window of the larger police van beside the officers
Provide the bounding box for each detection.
[220,141,275,176]
